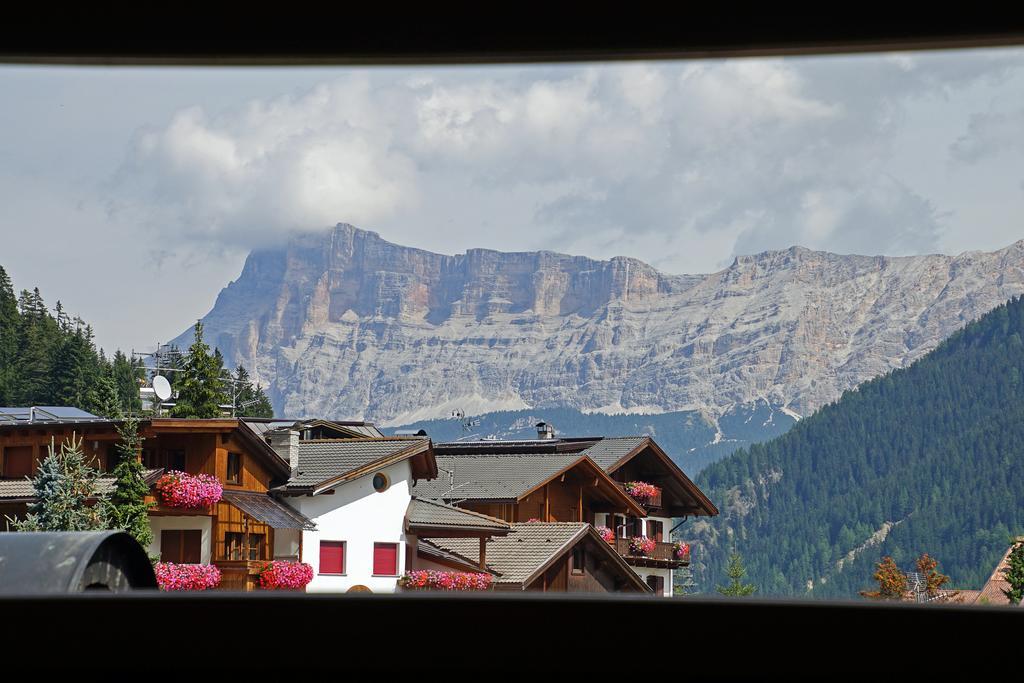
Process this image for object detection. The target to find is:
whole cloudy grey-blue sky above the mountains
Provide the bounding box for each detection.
[0,49,1024,350]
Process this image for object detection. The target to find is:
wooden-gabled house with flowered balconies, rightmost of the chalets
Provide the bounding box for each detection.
[416,432,718,596]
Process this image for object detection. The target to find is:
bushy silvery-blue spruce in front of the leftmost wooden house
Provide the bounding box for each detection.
[13,435,106,531]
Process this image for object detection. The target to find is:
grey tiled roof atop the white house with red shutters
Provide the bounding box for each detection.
[281,437,429,489]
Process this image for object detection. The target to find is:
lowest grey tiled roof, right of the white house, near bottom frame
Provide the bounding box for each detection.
[430,522,590,585]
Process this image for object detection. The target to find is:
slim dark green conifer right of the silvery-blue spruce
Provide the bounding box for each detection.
[105,418,153,548]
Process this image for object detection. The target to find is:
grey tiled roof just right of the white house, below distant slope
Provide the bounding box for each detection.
[413,453,582,500]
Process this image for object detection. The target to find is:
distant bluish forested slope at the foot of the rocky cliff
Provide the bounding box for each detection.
[385,402,796,476]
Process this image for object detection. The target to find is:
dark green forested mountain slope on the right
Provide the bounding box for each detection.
[684,298,1024,597]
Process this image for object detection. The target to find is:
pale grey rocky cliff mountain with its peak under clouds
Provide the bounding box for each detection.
[175,224,1024,425]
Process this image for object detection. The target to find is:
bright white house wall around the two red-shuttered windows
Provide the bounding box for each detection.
[288,460,412,593]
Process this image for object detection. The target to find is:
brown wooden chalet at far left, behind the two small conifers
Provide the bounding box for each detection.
[0,408,313,590]
